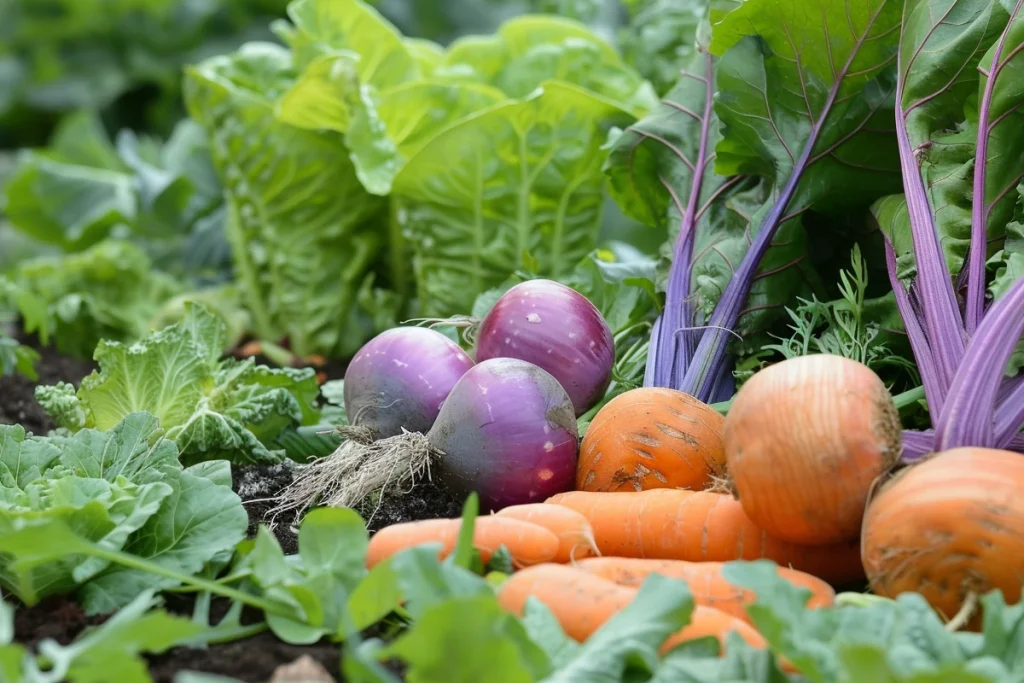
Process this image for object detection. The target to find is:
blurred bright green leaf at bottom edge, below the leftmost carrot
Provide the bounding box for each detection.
[385,595,549,683]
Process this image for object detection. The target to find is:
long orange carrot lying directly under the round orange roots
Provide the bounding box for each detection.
[548,488,864,586]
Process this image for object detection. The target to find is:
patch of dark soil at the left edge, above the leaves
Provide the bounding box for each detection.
[0,334,96,434]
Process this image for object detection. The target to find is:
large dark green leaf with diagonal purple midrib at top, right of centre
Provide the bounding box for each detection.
[711,0,901,211]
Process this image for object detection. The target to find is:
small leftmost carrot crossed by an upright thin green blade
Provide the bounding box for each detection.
[367,515,559,567]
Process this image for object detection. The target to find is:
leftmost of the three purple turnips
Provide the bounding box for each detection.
[345,327,473,439]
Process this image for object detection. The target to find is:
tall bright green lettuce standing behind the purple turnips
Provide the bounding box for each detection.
[186,0,654,355]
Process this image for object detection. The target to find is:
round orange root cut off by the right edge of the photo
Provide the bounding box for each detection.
[863,447,1024,628]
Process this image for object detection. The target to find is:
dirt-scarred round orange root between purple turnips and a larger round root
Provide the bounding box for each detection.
[577,387,725,492]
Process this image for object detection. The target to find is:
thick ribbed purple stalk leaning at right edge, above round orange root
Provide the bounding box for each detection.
[933,280,1024,451]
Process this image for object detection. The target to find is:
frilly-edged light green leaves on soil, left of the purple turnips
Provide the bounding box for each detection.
[36,303,318,464]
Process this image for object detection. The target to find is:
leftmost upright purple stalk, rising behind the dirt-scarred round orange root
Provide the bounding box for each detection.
[644,50,715,388]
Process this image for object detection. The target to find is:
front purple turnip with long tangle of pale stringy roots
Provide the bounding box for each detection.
[274,358,579,511]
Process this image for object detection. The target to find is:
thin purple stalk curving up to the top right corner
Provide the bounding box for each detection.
[964,0,1024,335]
